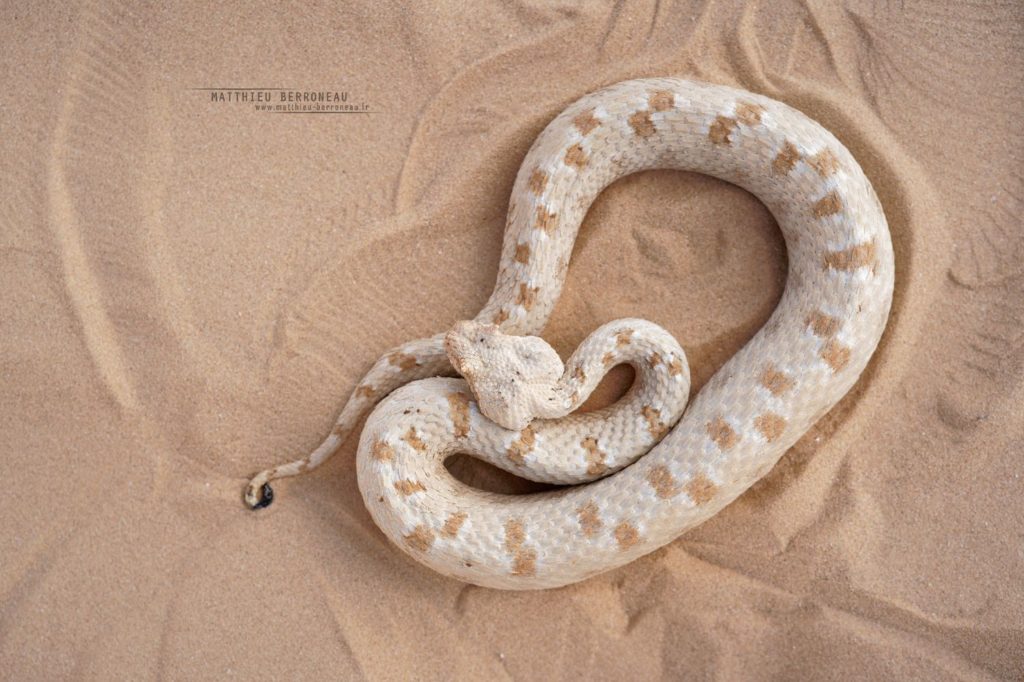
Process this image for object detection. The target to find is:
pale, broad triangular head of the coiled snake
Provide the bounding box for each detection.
[444,322,565,430]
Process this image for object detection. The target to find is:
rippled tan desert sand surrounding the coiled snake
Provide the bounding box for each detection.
[0,0,1024,680]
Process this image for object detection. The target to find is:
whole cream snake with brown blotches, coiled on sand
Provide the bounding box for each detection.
[246,78,894,589]
